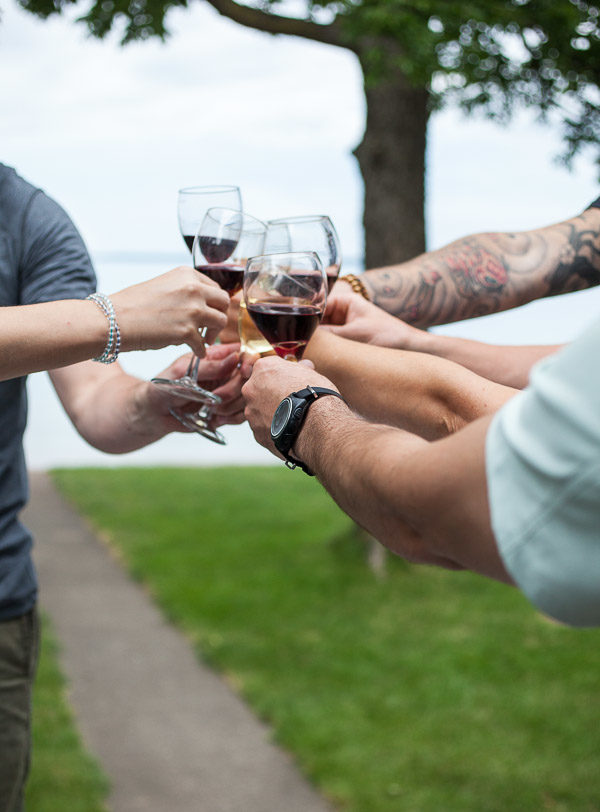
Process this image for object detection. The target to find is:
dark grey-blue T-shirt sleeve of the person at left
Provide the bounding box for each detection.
[20,190,96,304]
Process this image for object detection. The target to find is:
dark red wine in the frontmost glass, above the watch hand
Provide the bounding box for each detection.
[248,302,323,360]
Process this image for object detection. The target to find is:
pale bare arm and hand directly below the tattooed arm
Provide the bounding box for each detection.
[325,294,560,389]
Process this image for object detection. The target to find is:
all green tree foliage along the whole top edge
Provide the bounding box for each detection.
[19,0,600,169]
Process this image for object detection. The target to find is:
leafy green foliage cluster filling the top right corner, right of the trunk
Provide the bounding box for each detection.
[344,0,600,169]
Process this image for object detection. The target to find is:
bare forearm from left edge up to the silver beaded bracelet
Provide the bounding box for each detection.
[0,299,108,380]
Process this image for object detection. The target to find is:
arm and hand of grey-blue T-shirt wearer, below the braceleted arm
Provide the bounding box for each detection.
[50,344,243,454]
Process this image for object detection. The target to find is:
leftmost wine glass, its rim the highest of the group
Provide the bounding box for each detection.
[152,186,242,404]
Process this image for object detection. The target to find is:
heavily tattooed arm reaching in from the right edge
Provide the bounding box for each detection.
[350,208,600,326]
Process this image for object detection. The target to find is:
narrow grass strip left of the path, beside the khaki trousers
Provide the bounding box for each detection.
[25,621,108,812]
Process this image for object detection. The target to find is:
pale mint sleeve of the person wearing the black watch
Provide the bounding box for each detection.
[486,321,600,626]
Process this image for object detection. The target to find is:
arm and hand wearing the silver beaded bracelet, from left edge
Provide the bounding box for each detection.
[0,267,229,380]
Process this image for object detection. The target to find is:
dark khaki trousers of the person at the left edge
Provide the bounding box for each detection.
[0,609,39,812]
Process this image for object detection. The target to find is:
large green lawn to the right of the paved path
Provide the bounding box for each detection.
[54,467,600,812]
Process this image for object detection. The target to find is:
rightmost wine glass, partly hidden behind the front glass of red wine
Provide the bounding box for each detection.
[265,214,342,293]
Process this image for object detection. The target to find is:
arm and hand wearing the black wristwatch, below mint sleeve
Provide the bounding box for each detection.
[242,358,510,583]
